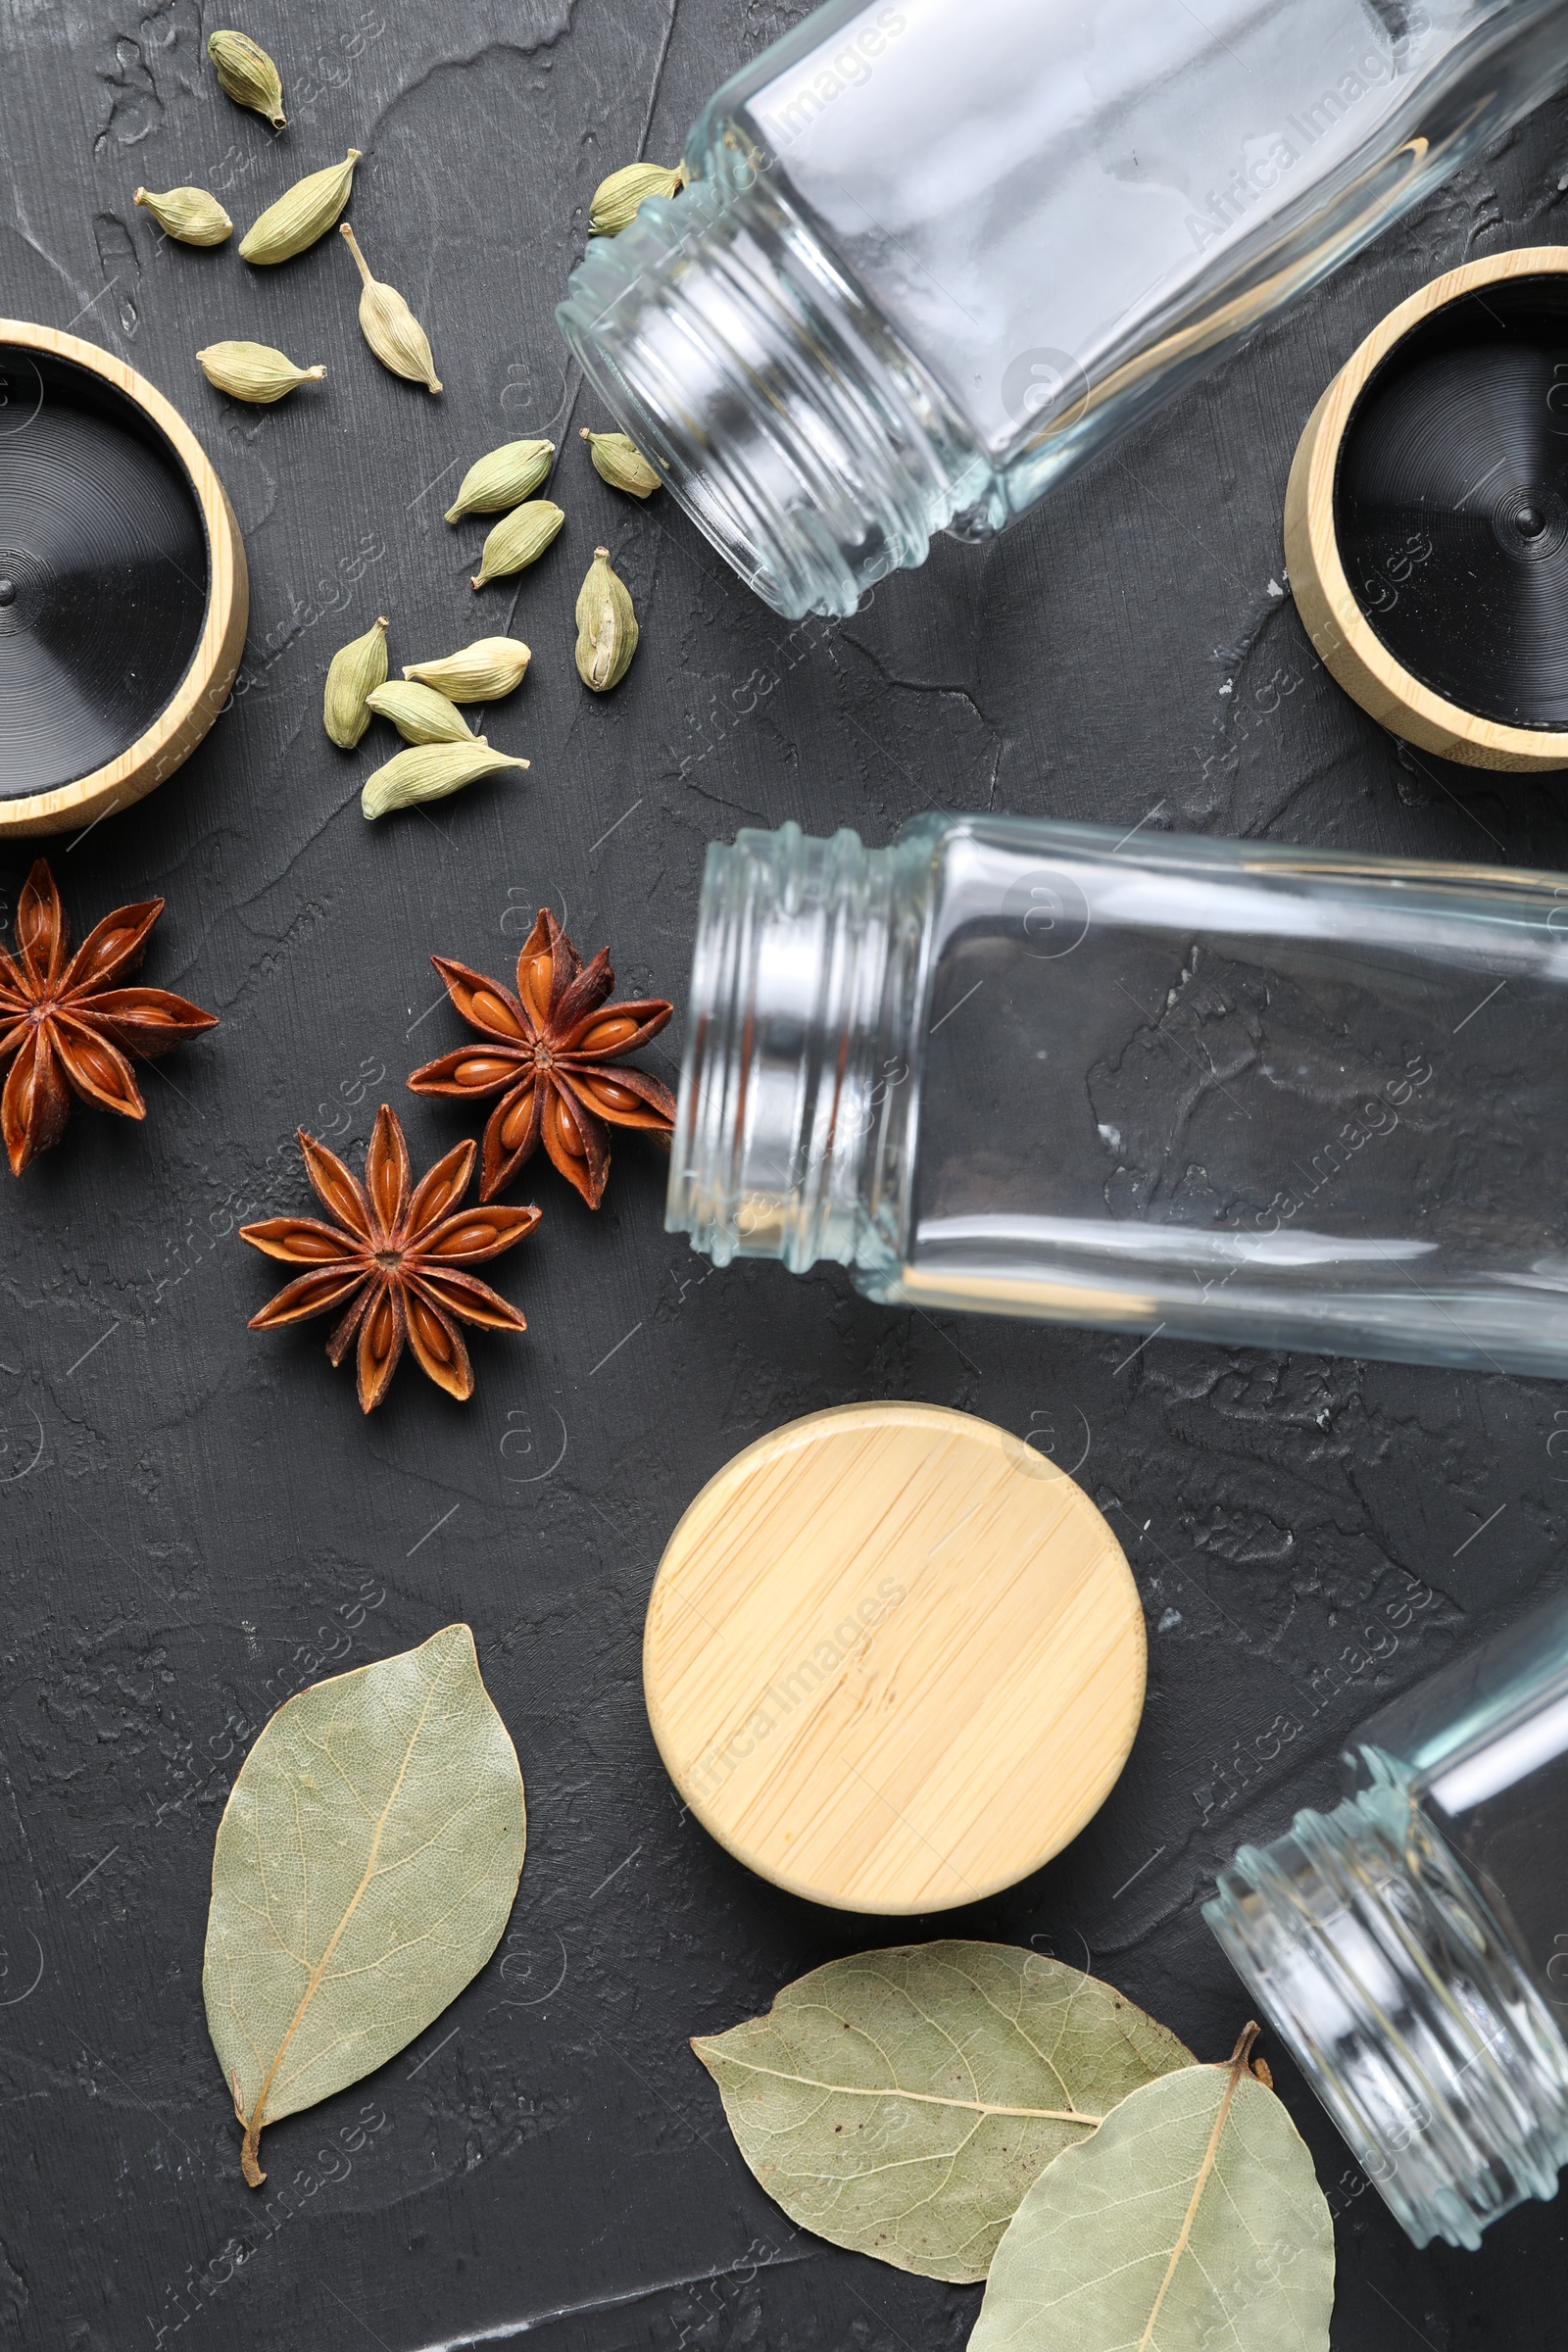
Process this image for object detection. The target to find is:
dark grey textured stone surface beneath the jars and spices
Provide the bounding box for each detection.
[0,0,1568,2352]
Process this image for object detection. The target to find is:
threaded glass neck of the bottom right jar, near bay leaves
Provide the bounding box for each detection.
[1203,1783,1568,2248]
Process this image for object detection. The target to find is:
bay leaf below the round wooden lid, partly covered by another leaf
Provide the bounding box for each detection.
[691,1940,1197,2279]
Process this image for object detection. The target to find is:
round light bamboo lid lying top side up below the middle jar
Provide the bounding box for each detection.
[642,1404,1148,1912]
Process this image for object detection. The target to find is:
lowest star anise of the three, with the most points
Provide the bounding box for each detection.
[240,1103,538,1413]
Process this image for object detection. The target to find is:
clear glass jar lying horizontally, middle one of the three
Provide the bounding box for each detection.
[665,816,1568,1373]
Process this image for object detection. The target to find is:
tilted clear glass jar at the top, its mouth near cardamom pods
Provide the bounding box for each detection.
[558,0,1568,618]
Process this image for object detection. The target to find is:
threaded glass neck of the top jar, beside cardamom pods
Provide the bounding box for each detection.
[558,174,1002,621]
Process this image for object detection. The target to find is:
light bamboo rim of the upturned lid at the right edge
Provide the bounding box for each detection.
[1286,245,1568,771]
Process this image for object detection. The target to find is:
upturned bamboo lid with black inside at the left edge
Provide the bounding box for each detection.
[0,319,249,837]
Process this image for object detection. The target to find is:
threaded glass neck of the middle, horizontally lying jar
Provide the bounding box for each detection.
[665,821,941,1275]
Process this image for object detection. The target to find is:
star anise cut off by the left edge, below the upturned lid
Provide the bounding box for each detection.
[0,858,219,1176]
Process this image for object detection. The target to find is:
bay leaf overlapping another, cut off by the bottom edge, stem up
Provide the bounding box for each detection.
[968,2025,1333,2352]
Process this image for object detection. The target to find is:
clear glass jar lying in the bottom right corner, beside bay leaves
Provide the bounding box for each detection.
[1203,1599,1568,2246]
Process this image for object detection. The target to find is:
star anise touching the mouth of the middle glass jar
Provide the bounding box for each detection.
[409,906,674,1209]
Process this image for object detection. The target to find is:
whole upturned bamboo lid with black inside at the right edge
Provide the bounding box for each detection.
[1286,245,1568,771]
